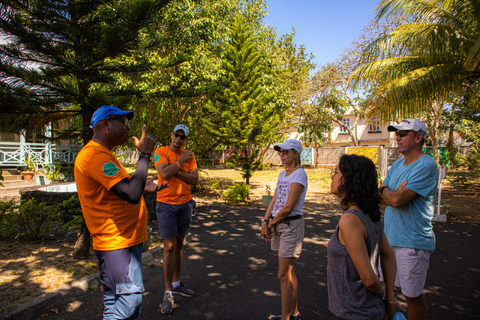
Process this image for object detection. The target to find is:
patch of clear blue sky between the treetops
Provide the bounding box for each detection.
[265,0,380,69]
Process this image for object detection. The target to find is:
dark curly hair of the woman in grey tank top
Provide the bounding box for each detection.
[338,154,381,221]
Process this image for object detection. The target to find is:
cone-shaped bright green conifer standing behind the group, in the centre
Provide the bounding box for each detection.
[204,17,283,184]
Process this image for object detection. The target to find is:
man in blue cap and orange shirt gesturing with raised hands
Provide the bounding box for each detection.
[75,106,166,320]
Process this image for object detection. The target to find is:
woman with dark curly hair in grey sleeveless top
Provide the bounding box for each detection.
[327,155,402,320]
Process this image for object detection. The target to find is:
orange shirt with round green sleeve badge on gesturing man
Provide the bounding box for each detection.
[74,140,148,251]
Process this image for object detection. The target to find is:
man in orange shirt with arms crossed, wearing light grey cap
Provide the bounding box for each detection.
[155,124,198,314]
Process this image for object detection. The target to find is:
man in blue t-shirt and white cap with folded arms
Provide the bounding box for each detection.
[380,119,438,320]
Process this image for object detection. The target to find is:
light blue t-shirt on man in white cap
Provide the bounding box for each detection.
[383,155,438,251]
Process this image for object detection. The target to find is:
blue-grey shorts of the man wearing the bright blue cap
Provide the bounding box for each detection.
[94,243,145,320]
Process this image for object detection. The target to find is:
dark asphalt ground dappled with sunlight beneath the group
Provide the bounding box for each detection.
[25,206,480,320]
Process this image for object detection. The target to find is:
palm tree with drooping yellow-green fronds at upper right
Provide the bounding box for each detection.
[351,0,480,159]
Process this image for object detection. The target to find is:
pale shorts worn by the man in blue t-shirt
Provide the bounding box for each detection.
[392,247,432,298]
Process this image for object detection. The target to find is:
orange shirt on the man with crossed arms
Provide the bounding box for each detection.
[154,146,197,205]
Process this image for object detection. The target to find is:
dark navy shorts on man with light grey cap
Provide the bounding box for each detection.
[155,200,195,240]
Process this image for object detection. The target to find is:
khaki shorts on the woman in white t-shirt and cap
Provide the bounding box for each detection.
[272,217,305,258]
